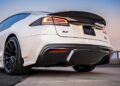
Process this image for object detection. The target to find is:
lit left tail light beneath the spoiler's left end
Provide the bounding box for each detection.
[42,16,69,26]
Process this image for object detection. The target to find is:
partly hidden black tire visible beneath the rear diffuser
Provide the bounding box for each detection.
[73,65,95,72]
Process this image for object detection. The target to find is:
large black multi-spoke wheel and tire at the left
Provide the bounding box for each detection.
[3,36,31,75]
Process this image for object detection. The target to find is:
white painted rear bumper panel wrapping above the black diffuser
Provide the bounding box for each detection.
[19,35,111,66]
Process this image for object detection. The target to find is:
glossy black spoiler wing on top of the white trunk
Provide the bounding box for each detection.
[49,11,106,25]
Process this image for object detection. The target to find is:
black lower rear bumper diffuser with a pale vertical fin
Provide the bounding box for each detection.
[34,44,111,66]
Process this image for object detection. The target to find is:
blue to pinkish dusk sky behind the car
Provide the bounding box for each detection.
[0,0,120,50]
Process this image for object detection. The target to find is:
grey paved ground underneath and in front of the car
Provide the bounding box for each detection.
[0,65,120,86]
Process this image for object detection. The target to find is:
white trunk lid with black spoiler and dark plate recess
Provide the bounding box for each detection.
[50,11,107,41]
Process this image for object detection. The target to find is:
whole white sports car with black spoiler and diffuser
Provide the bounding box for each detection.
[0,11,112,74]
